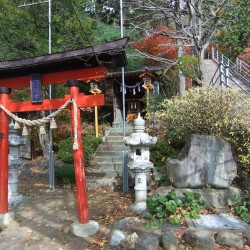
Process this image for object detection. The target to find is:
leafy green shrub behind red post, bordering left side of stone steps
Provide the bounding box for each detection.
[57,130,101,167]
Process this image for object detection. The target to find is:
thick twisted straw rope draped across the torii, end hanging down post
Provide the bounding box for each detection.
[0,99,78,150]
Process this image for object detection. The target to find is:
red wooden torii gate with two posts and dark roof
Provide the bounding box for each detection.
[0,38,127,229]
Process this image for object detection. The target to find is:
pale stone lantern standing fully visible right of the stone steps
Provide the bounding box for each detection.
[124,114,157,212]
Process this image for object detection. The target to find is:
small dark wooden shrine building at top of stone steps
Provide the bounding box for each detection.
[105,66,162,126]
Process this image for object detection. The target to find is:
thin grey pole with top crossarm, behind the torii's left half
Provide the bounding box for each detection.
[18,0,55,191]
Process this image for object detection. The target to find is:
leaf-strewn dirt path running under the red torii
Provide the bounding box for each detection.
[0,176,135,250]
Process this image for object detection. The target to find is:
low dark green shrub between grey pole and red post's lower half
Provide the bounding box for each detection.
[55,164,75,184]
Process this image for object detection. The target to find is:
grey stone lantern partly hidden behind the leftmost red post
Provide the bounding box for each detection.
[8,122,26,204]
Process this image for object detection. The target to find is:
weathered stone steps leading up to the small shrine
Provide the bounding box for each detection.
[86,126,134,188]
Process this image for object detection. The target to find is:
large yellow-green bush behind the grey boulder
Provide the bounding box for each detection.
[157,87,250,176]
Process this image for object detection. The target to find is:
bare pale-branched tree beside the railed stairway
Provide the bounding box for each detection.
[128,0,230,83]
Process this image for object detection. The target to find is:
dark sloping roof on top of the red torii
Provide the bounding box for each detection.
[0,38,128,79]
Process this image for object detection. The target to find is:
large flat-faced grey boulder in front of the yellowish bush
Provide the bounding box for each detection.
[166,134,237,188]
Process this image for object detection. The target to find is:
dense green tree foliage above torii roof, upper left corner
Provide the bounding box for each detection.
[0,0,96,60]
